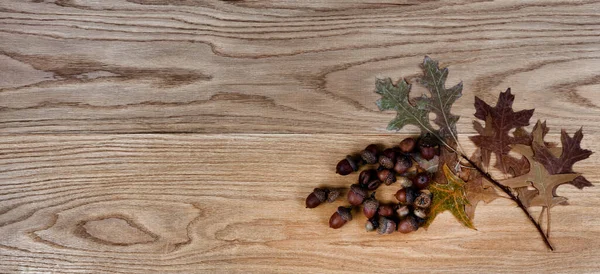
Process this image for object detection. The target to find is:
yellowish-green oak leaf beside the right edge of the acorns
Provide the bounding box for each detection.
[423,164,475,229]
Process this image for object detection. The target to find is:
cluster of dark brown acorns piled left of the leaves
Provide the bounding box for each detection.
[306,135,439,234]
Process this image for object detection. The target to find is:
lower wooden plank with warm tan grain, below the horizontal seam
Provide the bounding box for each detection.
[0,134,600,272]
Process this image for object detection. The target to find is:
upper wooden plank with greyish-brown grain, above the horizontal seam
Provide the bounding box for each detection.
[0,0,600,134]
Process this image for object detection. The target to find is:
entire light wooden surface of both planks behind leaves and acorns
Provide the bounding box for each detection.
[0,0,600,273]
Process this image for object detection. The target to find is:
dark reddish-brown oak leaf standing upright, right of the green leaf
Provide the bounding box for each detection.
[470,88,533,175]
